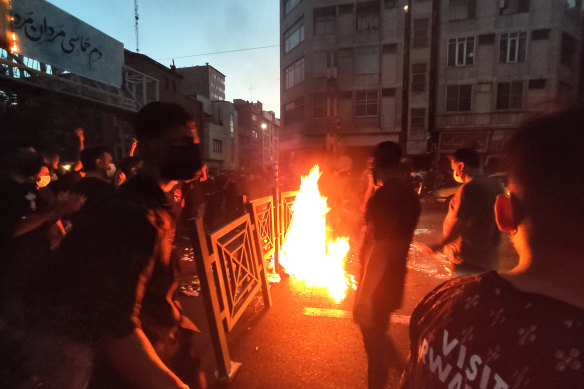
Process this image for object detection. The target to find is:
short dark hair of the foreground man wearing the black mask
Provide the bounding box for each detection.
[134,101,193,140]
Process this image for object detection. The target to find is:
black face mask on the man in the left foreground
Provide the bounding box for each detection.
[160,141,201,181]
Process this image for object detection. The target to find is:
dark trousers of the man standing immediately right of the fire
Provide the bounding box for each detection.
[360,323,404,389]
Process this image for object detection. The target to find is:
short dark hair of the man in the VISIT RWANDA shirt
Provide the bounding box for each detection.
[504,104,584,246]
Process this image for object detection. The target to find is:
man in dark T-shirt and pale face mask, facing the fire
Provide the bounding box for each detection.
[426,149,503,274]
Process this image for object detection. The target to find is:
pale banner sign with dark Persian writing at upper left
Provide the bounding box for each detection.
[12,0,124,87]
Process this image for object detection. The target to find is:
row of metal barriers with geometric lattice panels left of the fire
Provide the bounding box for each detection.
[192,189,298,382]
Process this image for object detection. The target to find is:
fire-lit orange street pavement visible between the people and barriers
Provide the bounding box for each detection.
[179,204,516,389]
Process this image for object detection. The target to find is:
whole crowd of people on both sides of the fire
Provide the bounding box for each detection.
[0,102,584,389]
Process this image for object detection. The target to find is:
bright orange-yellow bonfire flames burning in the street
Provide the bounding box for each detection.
[280,165,349,302]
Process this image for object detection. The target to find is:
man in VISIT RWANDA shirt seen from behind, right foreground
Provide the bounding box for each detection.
[402,106,584,389]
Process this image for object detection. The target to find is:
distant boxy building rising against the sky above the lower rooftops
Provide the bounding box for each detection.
[176,63,225,101]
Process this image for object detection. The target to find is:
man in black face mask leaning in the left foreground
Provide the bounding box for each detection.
[0,102,205,389]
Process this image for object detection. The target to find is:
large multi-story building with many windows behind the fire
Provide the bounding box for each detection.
[280,0,583,171]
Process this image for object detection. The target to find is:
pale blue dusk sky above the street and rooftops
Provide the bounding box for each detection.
[49,0,280,117]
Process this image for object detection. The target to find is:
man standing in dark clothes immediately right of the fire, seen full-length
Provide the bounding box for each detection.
[353,141,420,389]
